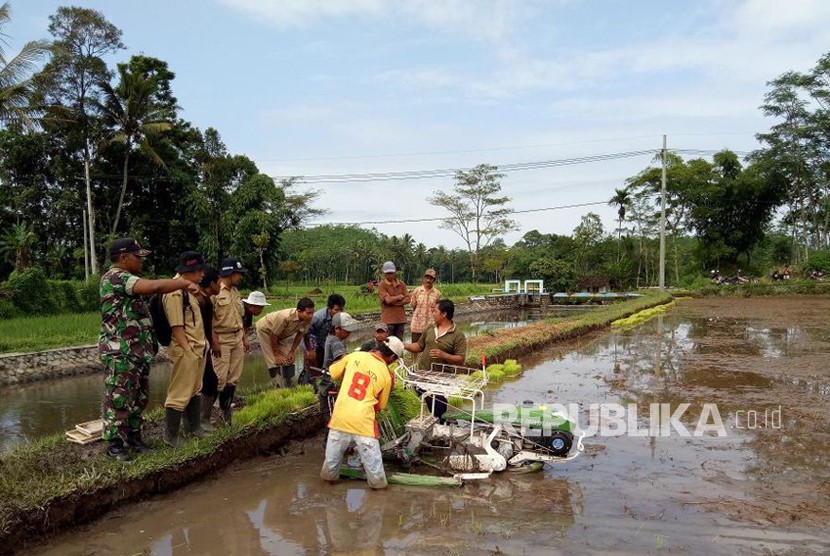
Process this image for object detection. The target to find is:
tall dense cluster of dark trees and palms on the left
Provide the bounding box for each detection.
[0,3,323,278]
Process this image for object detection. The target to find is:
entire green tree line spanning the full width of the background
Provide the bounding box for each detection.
[0,4,830,290]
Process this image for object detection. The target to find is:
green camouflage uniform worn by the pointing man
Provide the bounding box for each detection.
[98,267,158,441]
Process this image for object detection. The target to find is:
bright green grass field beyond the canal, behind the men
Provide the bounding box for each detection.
[0,284,494,353]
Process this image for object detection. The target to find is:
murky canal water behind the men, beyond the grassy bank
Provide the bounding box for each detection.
[0,309,592,451]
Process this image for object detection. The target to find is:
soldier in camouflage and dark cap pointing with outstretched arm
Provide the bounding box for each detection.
[98,238,198,461]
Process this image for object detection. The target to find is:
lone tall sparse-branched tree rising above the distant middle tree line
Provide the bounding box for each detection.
[429,164,519,281]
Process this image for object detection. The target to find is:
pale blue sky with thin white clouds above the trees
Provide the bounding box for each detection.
[4,0,830,247]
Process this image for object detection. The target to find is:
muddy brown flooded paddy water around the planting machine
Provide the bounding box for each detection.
[14,298,830,555]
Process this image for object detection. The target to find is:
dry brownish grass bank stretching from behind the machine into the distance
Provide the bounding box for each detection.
[466,291,672,367]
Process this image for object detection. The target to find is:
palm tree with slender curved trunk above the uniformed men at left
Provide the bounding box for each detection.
[96,65,173,233]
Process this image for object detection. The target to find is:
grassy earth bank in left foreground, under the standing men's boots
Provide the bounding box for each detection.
[0,386,323,554]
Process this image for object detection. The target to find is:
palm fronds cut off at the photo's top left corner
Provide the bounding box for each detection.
[0,2,51,127]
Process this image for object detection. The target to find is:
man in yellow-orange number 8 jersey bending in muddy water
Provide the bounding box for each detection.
[320,336,404,489]
